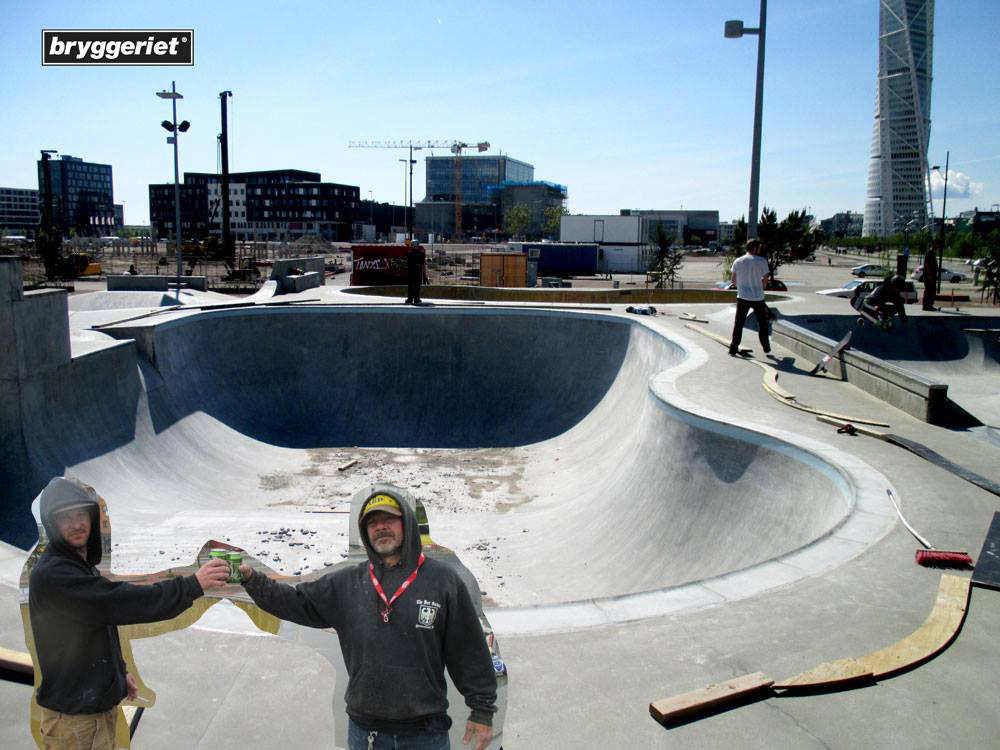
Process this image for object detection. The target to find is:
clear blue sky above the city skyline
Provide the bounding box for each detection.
[0,0,1000,223]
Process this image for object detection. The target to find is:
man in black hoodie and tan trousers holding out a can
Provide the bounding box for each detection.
[28,477,229,750]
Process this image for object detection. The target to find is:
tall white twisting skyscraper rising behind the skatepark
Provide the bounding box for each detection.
[862,0,934,237]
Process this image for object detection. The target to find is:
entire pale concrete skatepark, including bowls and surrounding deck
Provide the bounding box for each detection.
[0,256,1000,750]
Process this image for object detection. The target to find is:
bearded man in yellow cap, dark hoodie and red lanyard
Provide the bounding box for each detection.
[241,490,497,750]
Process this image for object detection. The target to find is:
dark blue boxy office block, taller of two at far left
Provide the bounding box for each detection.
[38,154,115,236]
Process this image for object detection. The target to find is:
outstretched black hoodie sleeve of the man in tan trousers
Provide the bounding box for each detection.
[31,564,203,625]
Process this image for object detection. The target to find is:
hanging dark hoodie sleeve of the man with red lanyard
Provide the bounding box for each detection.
[444,581,497,726]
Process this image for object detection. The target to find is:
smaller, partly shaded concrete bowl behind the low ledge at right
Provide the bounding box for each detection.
[785,314,1000,427]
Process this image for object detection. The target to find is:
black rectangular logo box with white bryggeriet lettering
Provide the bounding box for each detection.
[42,29,194,65]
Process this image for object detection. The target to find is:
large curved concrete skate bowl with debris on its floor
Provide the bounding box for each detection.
[5,307,884,607]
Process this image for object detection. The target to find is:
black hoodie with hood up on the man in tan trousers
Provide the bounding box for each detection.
[28,477,202,714]
